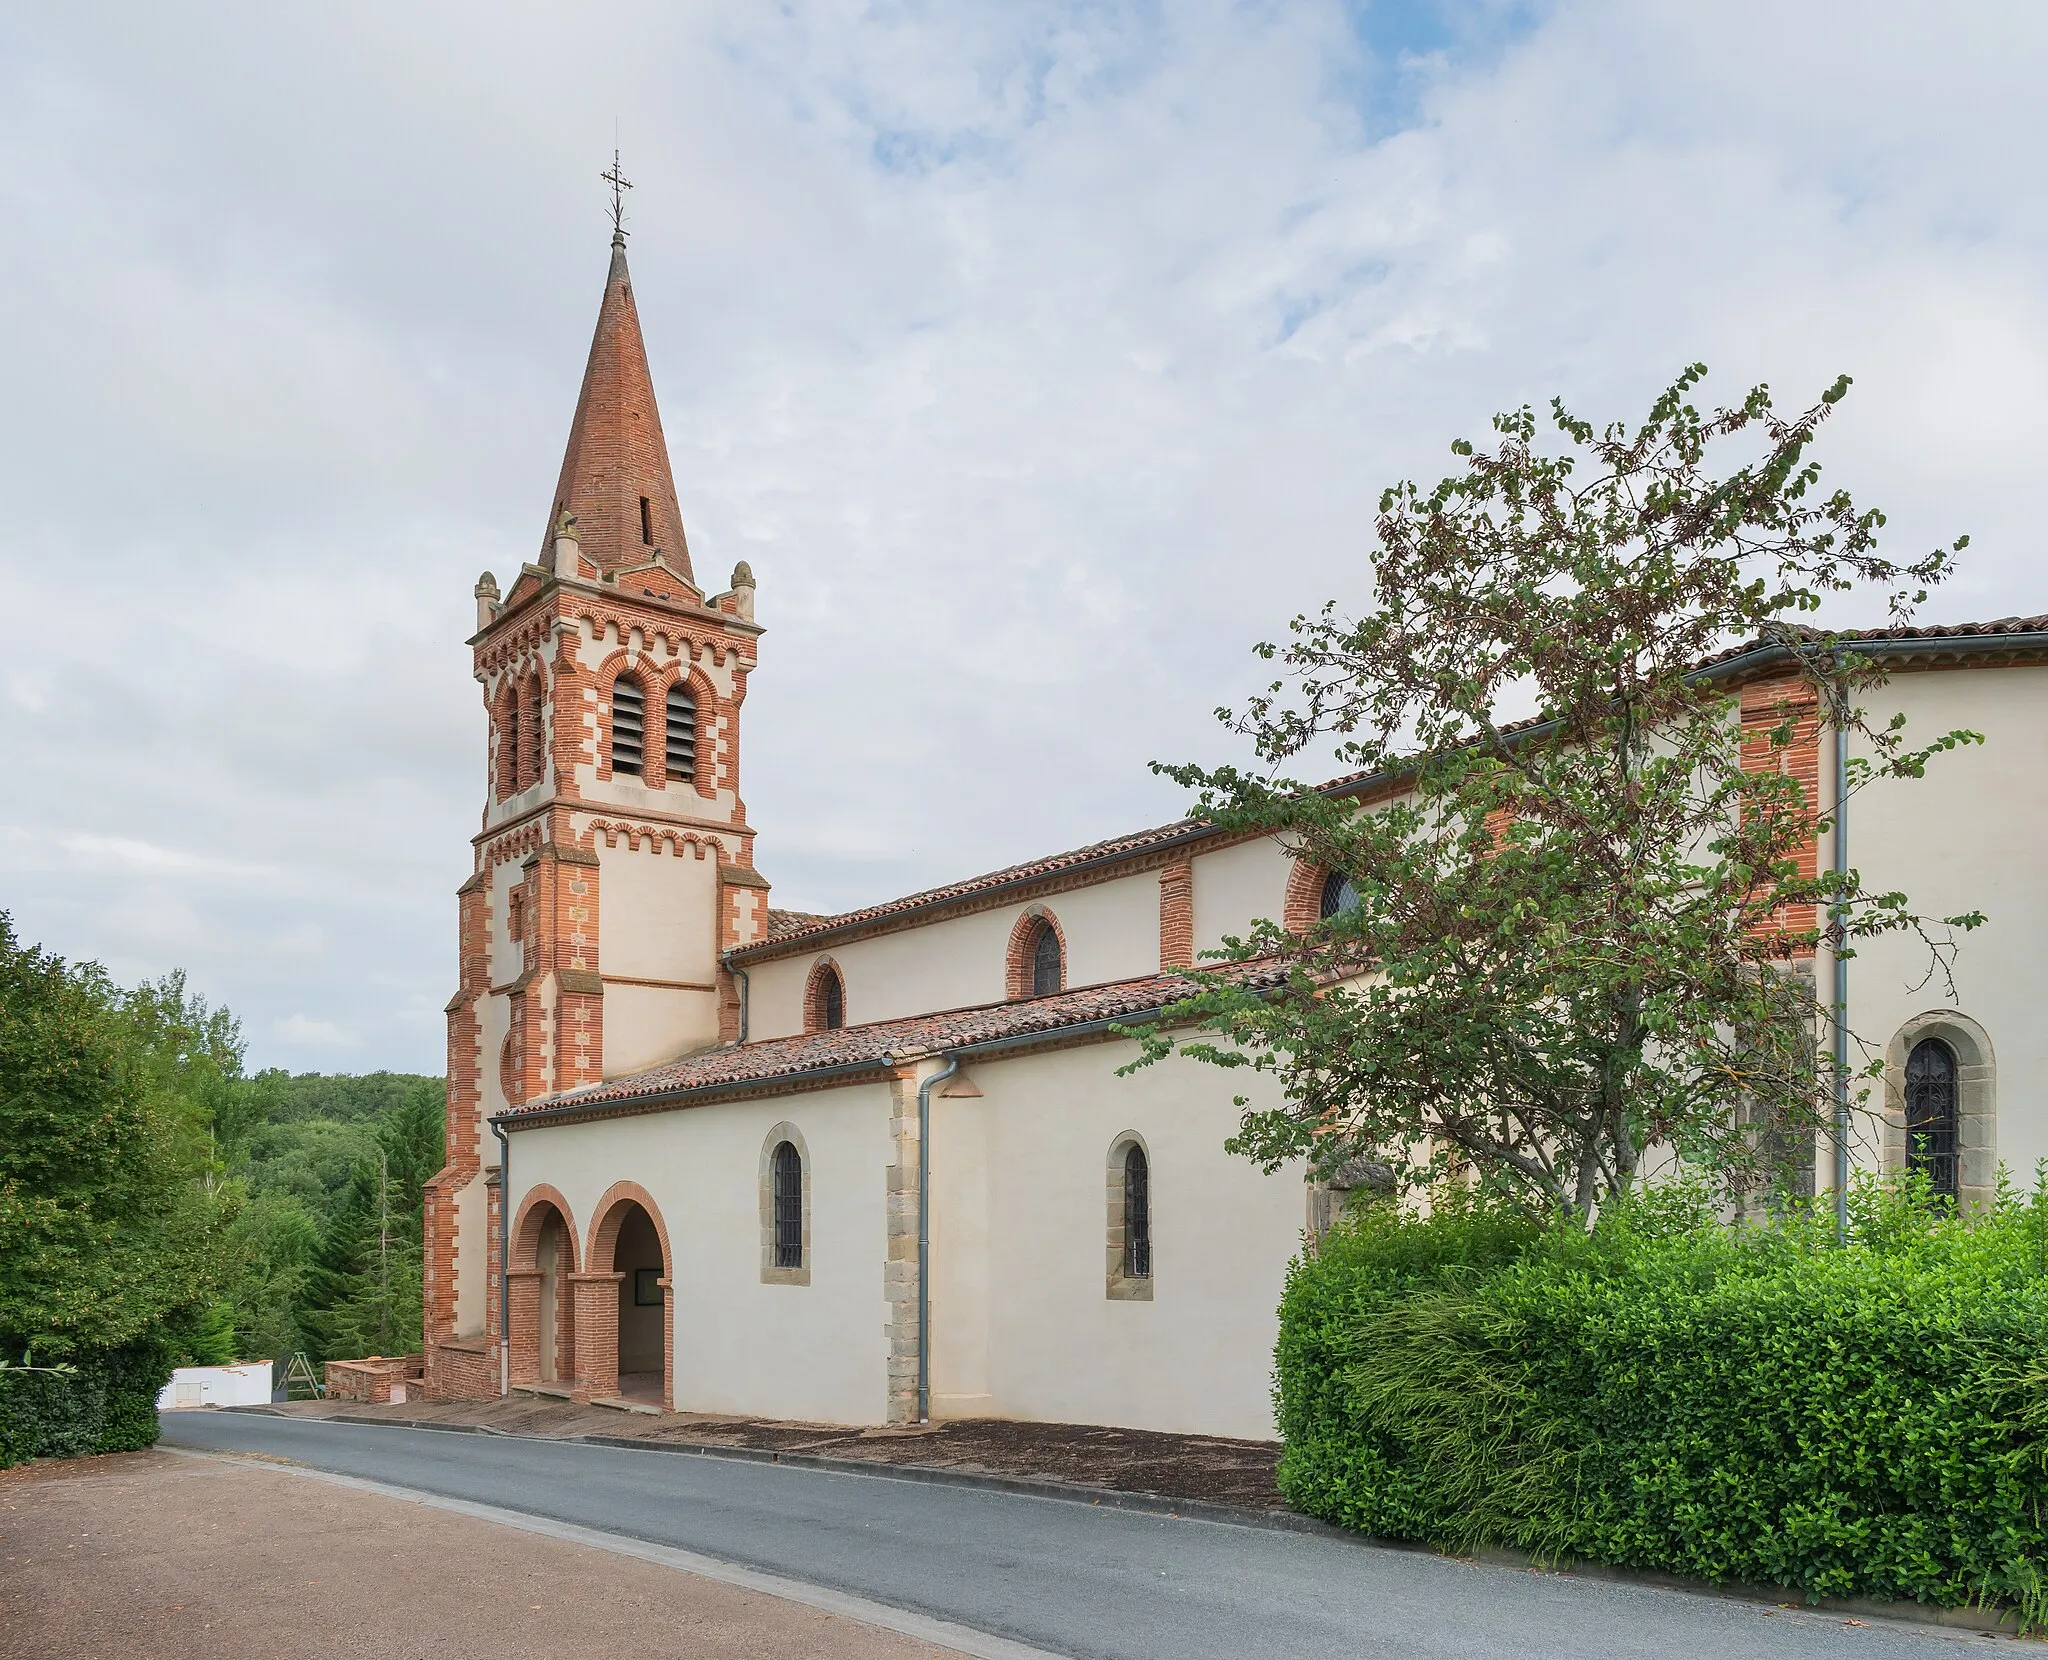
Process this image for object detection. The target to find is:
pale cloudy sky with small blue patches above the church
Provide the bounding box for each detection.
[0,0,2048,1071]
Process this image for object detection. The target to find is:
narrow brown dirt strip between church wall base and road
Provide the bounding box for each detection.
[272,1394,1284,1511]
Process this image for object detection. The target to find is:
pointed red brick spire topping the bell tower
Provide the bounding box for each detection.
[541,229,696,581]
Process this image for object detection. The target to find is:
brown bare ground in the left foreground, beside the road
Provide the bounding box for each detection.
[0,1453,970,1660]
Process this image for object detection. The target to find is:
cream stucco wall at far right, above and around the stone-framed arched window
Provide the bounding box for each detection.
[1823,667,2048,1181]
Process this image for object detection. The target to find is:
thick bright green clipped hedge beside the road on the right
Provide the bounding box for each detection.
[1276,1187,2048,1625]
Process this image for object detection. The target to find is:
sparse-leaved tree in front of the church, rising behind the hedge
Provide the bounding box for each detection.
[1139,376,1982,1224]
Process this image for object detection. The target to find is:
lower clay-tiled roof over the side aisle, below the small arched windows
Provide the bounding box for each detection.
[504,966,1284,1120]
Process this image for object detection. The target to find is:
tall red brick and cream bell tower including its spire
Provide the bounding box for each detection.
[426,213,768,1396]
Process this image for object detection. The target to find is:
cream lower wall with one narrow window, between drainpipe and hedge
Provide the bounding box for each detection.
[932,1044,1307,1437]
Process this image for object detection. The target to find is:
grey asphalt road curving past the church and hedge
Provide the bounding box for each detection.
[164,1412,1993,1660]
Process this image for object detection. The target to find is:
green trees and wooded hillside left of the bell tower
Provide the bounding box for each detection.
[0,913,444,1394]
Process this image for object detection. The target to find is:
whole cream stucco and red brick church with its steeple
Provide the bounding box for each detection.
[426,221,2048,1437]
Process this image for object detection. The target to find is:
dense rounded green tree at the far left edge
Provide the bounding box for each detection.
[0,913,225,1359]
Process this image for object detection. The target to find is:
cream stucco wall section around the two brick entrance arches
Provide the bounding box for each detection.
[499,1085,889,1425]
